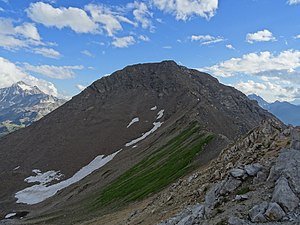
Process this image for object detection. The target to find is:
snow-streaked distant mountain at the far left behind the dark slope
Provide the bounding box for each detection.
[0,81,65,136]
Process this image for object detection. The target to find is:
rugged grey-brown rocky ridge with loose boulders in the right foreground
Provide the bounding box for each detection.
[155,118,300,225]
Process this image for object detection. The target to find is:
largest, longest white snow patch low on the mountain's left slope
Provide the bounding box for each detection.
[15,149,122,205]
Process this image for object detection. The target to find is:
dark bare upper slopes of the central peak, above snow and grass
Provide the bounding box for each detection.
[0,61,273,214]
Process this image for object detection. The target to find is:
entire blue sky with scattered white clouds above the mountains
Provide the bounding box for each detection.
[0,0,300,104]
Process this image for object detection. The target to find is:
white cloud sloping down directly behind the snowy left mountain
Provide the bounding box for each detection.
[0,57,58,96]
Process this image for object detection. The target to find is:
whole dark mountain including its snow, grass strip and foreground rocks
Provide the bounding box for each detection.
[0,61,276,224]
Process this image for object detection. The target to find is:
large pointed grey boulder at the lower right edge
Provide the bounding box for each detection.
[272,176,299,212]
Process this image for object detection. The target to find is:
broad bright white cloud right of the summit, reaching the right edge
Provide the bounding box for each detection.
[200,50,300,77]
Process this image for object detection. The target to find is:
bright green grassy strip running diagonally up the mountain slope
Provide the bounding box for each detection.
[92,123,212,209]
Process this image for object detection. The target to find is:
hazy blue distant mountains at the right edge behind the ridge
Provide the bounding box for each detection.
[248,94,300,126]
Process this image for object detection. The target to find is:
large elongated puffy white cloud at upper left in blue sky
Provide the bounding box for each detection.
[26,2,98,33]
